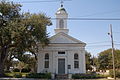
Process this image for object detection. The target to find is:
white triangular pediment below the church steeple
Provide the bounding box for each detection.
[50,32,85,44]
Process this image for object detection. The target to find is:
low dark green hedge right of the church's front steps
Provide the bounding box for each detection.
[72,73,104,79]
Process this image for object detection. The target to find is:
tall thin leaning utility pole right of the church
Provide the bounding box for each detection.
[108,24,116,80]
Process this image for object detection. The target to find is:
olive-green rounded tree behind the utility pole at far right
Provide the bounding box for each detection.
[98,49,120,70]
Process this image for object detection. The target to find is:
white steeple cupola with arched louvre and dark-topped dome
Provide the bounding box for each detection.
[55,4,69,34]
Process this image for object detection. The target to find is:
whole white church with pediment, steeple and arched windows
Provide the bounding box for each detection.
[37,5,86,76]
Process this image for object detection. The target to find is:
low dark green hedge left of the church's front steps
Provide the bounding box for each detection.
[26,73,51,79]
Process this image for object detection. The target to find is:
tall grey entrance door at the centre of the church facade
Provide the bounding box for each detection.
[58,59,65,74]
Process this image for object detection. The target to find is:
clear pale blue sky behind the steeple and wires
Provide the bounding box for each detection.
[10,0,120,56]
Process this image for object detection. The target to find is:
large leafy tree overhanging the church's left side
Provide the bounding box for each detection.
[0,0,51,77]
